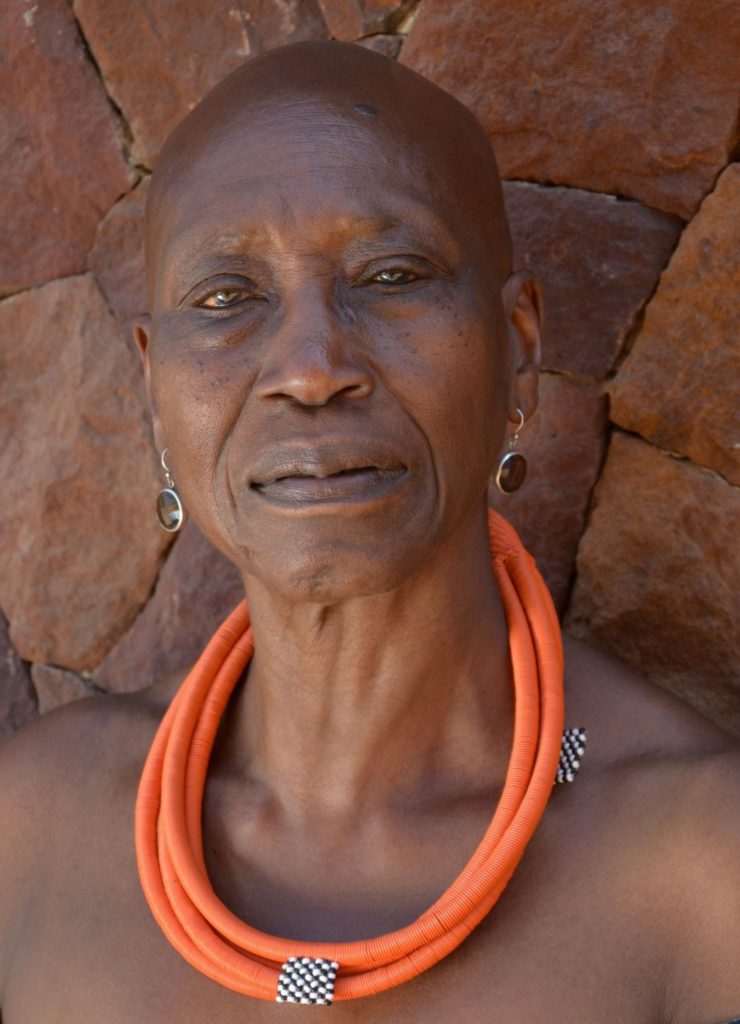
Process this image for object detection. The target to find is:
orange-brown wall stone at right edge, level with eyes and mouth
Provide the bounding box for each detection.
[611,164,740,484]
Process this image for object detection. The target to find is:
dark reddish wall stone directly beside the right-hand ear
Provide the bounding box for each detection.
[504,181,683,378]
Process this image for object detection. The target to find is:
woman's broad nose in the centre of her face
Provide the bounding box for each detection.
[255,290,375,407]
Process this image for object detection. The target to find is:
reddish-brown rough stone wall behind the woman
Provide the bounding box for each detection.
[0,0,740,734]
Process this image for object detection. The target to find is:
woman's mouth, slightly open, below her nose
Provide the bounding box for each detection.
[250,457,406,505]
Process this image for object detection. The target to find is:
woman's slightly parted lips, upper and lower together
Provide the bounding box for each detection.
[249,441,407,506]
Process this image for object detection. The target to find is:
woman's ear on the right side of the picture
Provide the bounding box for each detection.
[503,270,542,423]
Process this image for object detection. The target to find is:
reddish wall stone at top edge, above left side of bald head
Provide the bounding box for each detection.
[74,0,328,167]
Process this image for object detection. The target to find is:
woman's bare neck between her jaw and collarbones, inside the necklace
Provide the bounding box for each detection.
[222,499,514,817]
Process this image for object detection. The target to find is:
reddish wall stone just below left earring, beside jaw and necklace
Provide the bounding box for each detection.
[93,519,244,693]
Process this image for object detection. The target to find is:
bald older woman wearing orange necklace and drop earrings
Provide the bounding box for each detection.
[0,44,740,1024]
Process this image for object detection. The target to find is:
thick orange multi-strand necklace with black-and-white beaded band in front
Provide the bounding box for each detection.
[136,511,563,1005]
